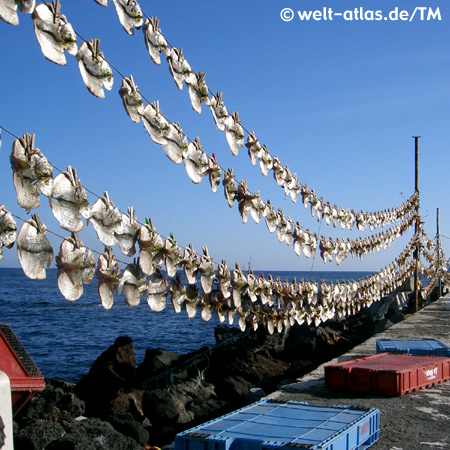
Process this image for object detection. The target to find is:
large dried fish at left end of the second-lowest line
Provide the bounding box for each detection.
[10,134,53,211]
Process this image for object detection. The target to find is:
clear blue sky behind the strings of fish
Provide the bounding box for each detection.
[0,0,450,270]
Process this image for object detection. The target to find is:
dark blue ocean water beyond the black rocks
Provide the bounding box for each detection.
[0,269,368,381]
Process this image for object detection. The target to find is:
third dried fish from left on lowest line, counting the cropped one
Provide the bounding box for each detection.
[56,234,95,302]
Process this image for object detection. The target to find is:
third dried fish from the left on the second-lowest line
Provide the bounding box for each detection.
[83,192,122,247]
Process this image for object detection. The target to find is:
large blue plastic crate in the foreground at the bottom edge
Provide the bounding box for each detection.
[175,400,380,450]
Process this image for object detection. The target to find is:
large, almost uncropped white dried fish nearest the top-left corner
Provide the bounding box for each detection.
[33,0,78,66]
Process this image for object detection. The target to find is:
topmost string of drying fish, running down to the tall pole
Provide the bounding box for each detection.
[87,1,419,231]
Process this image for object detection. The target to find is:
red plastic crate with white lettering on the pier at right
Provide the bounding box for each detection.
[325,353,450,396]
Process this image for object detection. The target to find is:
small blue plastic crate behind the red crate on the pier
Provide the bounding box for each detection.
[376,339,450,357]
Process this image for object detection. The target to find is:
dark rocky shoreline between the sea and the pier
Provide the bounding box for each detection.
[14,294,436,450]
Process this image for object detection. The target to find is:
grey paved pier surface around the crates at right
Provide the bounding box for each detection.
[269,296,450,450]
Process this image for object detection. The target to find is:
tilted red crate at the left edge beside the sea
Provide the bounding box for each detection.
[0,324,45,415]
